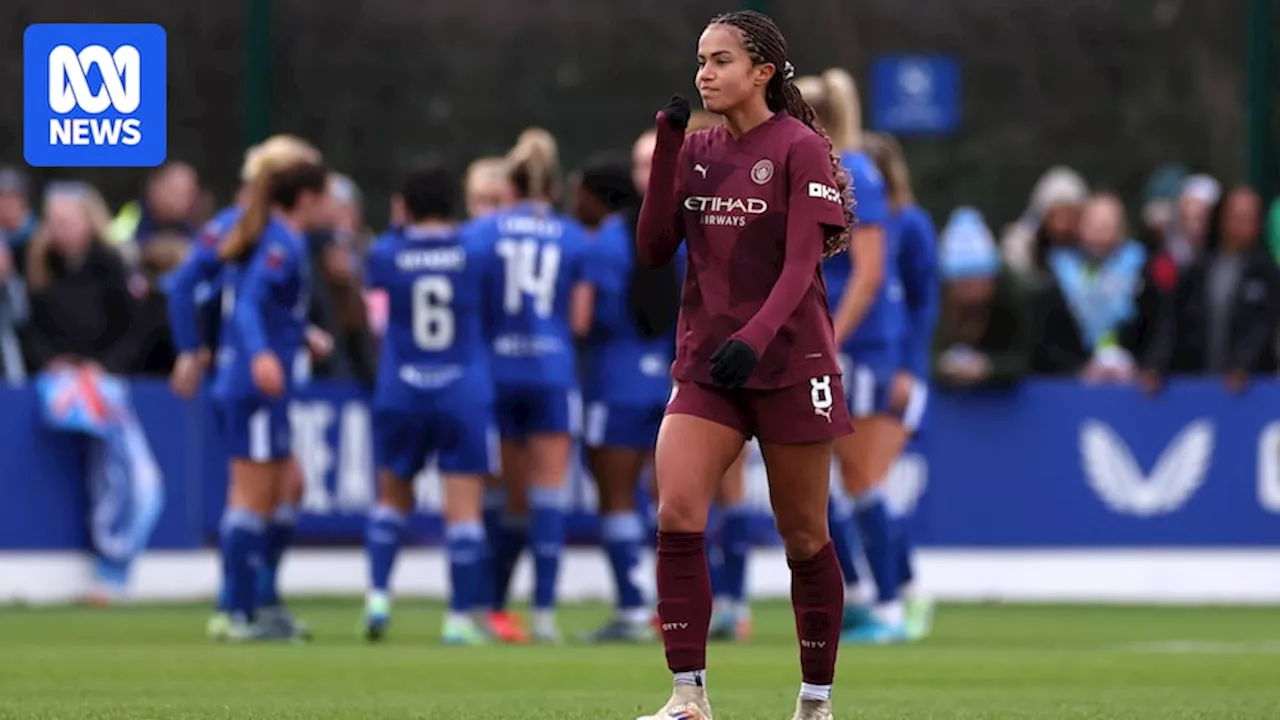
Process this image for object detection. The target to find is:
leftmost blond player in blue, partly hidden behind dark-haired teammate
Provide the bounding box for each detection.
[166,135,332,639]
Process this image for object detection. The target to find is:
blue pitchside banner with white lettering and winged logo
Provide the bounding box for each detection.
[0,380,1280,551]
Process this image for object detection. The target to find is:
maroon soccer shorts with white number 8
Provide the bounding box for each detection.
[667,375,852,445]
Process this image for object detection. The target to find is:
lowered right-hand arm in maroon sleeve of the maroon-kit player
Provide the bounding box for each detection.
[732,136,845,357]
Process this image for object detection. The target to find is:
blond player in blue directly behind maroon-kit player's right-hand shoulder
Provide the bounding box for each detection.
[796,69,911,642]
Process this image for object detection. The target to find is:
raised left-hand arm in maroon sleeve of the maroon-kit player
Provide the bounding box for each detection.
[636,111,689,268]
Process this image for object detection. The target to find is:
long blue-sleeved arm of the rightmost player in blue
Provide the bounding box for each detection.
[899,211,941,378]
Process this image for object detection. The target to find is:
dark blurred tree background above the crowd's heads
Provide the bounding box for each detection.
[0,0,1280,224]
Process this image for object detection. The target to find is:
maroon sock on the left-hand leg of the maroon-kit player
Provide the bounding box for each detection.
[658,532,711,673]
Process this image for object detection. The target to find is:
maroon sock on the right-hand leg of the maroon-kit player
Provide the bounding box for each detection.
[787,542,845,685]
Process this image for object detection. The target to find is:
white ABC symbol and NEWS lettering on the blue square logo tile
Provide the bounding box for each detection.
[49,45,142,146]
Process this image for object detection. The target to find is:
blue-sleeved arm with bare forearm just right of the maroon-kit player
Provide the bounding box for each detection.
[831,155,888,347]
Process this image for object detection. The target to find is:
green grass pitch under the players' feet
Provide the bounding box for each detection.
[0,601,1280,720]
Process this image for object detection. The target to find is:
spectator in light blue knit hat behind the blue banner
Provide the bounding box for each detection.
[933,208,1034,388]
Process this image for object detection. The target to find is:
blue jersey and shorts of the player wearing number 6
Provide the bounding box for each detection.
[366,225,499,479]
